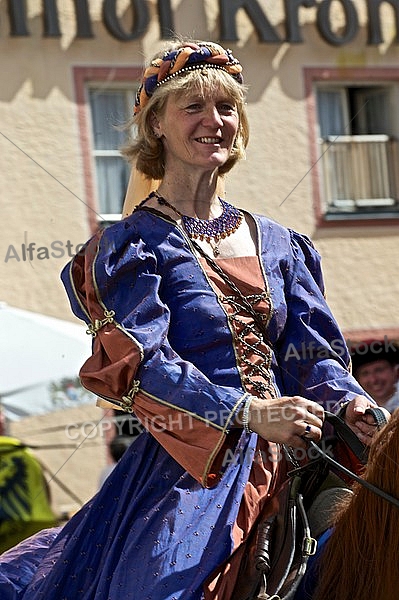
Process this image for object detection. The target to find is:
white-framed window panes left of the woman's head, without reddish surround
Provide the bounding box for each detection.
[88,84,135,225]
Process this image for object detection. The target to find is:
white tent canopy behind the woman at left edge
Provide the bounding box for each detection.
[0,302,92,419]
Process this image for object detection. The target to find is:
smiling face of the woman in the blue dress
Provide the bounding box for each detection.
[154,89,239,177]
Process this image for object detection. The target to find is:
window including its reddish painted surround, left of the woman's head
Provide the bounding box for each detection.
[73,65,142,233]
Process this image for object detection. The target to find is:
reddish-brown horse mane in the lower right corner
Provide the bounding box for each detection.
[313,409,399,600]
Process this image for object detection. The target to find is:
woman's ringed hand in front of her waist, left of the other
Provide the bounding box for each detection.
[248,396,324,448]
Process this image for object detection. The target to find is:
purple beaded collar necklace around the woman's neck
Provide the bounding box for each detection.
[149,191,243,257]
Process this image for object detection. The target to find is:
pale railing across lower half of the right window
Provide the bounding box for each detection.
[321,135,399,213]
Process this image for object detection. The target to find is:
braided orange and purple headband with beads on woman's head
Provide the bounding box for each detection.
[134,43,243,115]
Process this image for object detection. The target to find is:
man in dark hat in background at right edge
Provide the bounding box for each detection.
[351,340,399,412]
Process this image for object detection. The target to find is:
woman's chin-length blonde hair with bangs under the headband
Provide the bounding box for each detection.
[121,41,249,179]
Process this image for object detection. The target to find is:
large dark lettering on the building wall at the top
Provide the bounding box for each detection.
[8,0,399,46]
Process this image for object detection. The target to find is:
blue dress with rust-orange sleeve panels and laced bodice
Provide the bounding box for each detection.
[0,209,364,600]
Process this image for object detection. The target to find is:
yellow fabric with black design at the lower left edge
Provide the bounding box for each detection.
[0,436,56,552]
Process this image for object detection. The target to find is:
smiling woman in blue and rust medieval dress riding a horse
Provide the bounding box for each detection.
[0,40,382,600]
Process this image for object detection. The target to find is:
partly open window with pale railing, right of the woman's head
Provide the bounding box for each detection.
[315,82,399,219]
